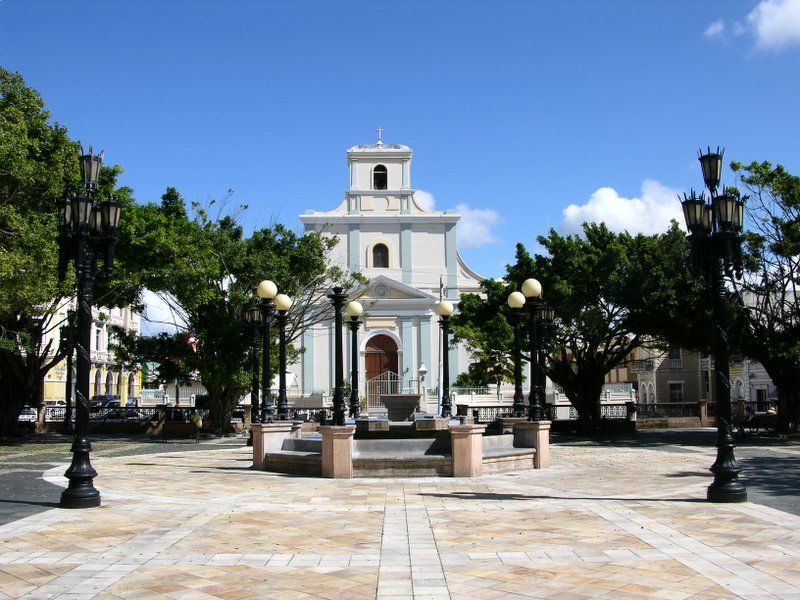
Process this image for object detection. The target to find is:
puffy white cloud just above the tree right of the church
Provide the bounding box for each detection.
[559,179,683,234]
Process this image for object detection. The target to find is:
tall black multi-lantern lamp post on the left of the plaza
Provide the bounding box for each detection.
[59,148,121,508]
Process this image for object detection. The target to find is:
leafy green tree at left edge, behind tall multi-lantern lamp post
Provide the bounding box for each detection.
[0,68,78,437]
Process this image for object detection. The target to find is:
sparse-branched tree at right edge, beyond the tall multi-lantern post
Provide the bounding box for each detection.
[731,162,800,431]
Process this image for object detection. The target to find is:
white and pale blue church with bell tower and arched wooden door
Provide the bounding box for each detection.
[290,133,481,406]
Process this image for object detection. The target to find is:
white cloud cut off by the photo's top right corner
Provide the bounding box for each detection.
[703,0,800,51]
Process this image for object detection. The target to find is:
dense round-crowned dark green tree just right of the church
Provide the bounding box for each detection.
[454,224,702,428]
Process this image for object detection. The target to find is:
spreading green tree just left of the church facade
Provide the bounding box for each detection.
[110,188,360,424]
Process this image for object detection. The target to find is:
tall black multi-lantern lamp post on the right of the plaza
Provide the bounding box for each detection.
[681,148,747,502]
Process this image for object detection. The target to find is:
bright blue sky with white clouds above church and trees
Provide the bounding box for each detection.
[0,0,800,284]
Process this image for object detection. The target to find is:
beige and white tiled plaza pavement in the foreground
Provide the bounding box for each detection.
[0,446,800,600]
